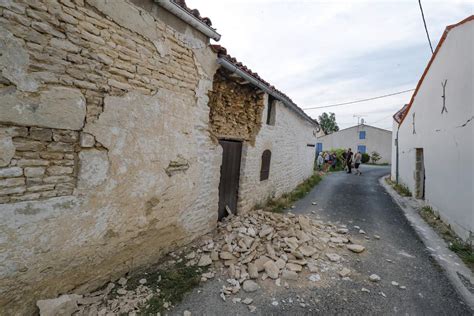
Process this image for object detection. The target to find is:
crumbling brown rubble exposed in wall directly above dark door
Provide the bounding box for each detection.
[209,69,264,144]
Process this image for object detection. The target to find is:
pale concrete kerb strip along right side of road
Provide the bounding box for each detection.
[379,175,474,311]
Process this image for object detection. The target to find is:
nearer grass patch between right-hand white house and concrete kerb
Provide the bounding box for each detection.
[418,206,474,272]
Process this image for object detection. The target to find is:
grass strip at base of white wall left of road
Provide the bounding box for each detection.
[255,173,322,213]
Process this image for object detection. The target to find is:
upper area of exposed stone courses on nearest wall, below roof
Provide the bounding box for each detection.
[0,0,197,121]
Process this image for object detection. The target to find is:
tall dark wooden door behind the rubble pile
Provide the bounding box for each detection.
[219,140,242,220]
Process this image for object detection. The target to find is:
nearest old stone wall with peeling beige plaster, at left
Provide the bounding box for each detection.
[0,0,221,314]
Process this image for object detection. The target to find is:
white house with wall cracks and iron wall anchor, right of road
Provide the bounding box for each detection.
[392,16,474,239]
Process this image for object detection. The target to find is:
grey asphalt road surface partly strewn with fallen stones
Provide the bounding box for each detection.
[170,166,472,315]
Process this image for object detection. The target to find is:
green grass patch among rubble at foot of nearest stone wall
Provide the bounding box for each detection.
[114,260,207,315]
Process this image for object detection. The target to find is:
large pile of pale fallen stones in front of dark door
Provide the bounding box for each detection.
[193,211,365,300]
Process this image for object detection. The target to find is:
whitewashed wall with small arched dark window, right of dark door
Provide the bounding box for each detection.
[238,98,316,212]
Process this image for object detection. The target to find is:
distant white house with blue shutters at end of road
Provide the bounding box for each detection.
[316,124,392,163]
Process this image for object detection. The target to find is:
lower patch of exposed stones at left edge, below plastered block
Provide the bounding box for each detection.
[0,125,79,203]
